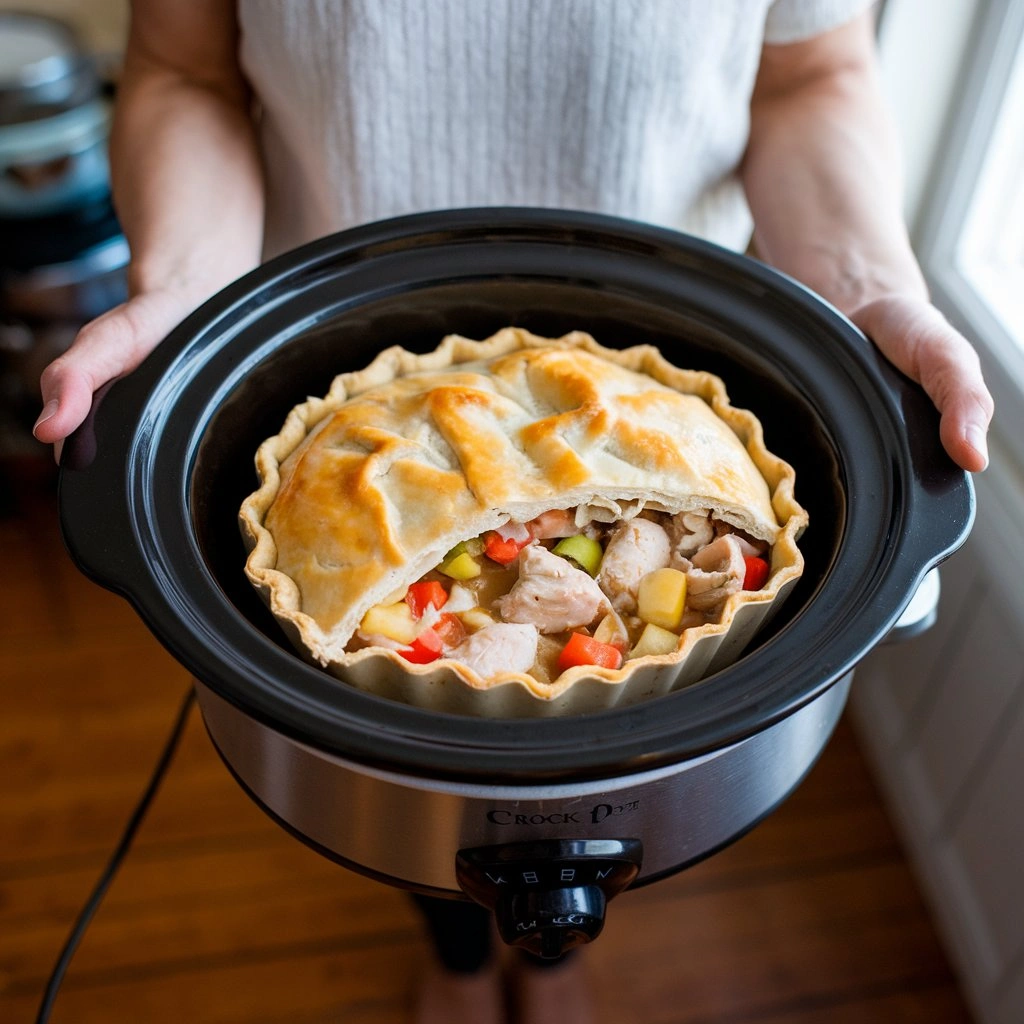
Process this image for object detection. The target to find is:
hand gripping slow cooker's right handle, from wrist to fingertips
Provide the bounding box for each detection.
[851,296,993,472]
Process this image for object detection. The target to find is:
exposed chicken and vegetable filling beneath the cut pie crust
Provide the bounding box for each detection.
[347,501,771,683]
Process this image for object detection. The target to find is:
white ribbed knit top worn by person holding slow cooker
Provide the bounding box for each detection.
[239,0,870,255]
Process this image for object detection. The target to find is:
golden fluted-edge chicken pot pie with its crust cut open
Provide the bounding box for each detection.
[240,328,807,716]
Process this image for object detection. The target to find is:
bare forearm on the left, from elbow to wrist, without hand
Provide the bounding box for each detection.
[111,51,263,303]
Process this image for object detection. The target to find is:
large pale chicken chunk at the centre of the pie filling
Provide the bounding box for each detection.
[497,544,608,633]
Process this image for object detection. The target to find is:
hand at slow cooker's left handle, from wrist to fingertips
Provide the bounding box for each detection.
[33,290,197,459]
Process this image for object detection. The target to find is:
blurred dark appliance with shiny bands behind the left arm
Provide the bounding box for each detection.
[0,11,128,457]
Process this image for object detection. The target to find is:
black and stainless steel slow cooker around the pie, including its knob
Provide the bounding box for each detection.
[59,208,974,956]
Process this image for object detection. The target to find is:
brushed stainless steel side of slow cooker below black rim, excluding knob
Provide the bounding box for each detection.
[196,673,852,895]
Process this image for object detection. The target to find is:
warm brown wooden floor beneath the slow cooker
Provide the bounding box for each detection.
[0,458,970,1024]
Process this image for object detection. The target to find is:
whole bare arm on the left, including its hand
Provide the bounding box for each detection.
[34,0,263,455]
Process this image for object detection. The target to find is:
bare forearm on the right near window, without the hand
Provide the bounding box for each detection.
[742,18,927,313]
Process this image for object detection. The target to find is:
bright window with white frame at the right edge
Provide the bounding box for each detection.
[914,0,1024,456]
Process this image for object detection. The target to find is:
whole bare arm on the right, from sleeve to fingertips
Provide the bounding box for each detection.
[741,14,992,471]
